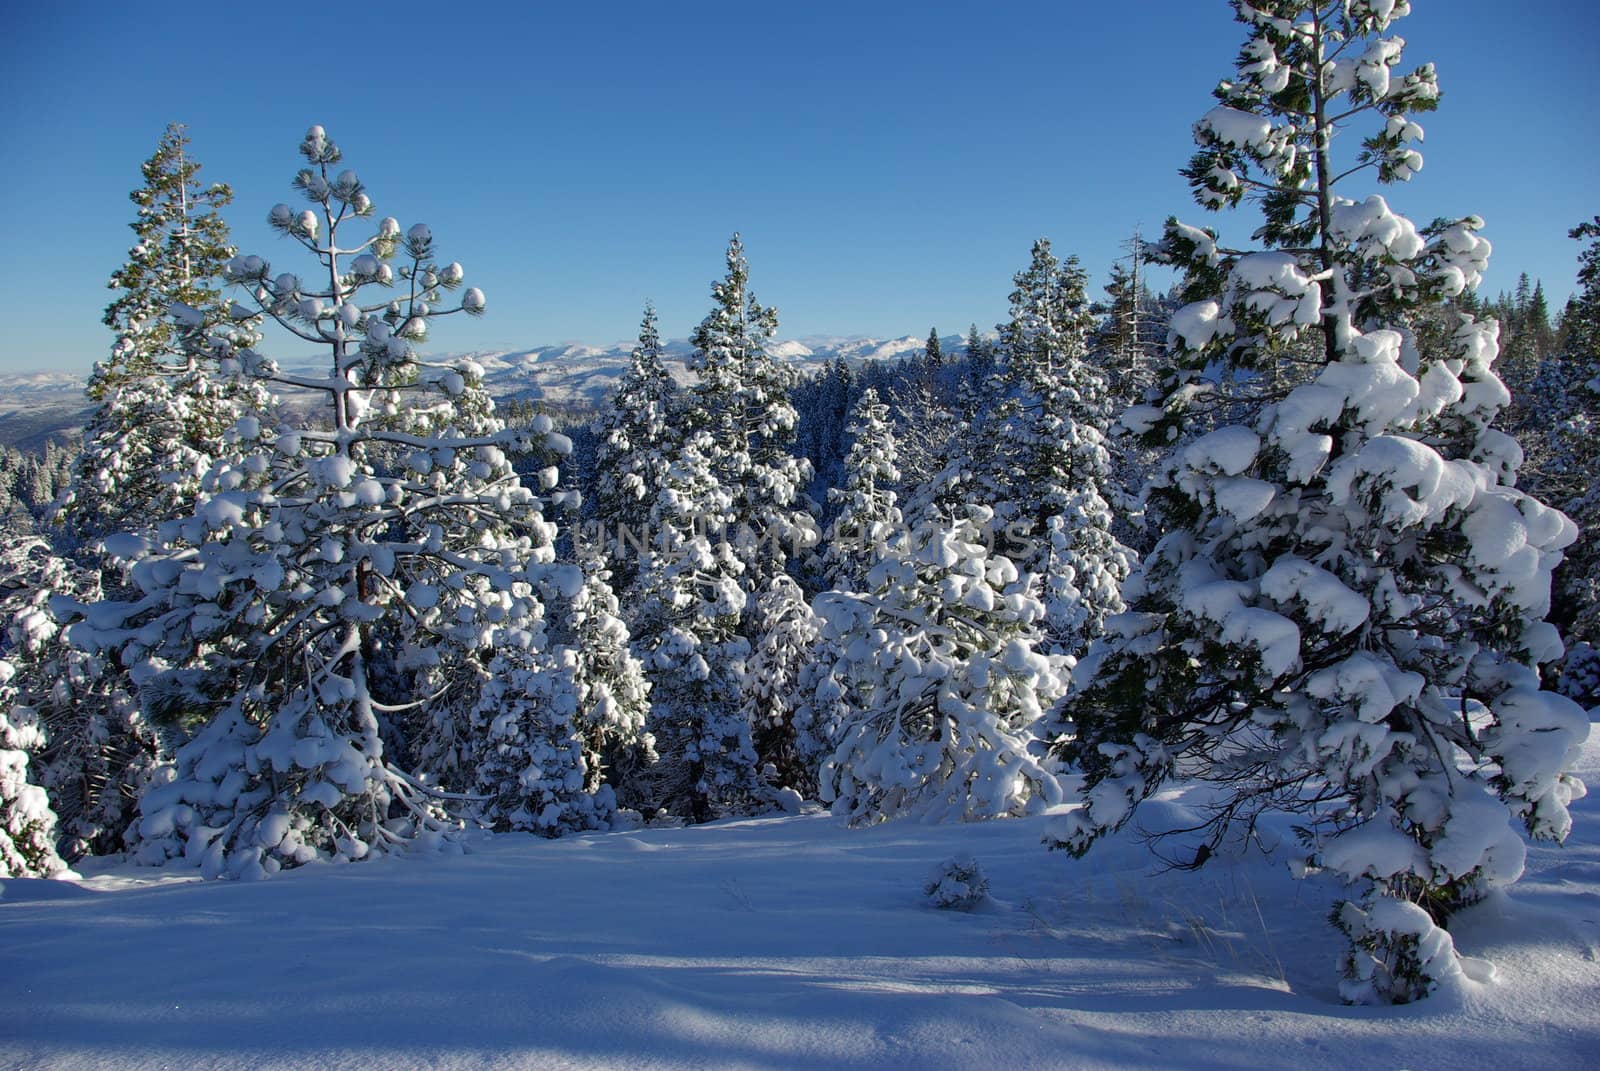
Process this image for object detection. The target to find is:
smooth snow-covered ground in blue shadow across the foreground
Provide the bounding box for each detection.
[0,717,1600,1071]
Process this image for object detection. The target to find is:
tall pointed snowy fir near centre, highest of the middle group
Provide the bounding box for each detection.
[635,235,816,821]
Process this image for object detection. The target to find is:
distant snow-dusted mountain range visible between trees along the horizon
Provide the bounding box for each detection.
[0,335,965,450]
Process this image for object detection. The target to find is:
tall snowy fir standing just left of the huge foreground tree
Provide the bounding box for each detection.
[984,239,1133,655]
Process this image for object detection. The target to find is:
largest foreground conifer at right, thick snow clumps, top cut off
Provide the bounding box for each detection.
[1054,0,1589,1002]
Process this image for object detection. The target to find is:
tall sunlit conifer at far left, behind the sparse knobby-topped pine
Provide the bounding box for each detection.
[56,123,259,540]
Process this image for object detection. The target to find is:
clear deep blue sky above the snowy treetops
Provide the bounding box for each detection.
[0,0,1600,371]
